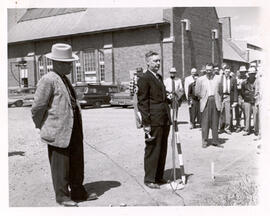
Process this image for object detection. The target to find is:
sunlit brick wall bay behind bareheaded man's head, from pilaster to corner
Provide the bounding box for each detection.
[113,24,172,82]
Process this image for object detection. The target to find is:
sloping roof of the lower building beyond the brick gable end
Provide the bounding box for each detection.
[222,39,248,63]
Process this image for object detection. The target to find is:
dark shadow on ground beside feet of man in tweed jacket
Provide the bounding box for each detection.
[84,181,121,196]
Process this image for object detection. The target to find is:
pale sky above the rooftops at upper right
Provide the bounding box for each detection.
[216,7,262,46]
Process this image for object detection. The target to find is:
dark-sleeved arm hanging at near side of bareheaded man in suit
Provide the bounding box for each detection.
[138,76,151,126]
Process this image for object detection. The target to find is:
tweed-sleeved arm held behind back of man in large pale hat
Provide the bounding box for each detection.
[31,77,53,129]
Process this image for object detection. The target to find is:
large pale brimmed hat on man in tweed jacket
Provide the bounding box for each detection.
[45,43,79,62]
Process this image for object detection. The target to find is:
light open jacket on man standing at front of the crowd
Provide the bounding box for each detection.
[195,75,221,112]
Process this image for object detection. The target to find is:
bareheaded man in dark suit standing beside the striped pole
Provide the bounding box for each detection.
[138,51,171,189]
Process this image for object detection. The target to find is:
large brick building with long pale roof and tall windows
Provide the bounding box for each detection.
[8,7,223,87]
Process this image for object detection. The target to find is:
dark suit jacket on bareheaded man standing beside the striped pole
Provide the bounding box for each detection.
[137,71,171,126]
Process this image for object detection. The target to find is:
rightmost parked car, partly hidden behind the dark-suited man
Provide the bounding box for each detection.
[110,89,133,108]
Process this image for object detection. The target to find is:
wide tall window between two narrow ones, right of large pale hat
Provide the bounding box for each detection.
[83,49,97,83]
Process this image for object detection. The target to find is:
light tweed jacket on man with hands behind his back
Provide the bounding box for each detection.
[31,72,82,148]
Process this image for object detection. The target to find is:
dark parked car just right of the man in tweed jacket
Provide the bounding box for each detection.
[74,84,118,108]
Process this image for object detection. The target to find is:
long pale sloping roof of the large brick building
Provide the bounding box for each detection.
[8,8,166,43]
